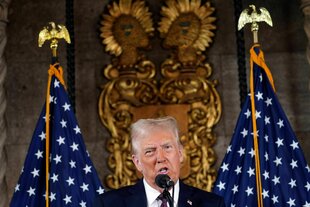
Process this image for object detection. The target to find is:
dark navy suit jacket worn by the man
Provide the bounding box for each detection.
[93,180,225,207]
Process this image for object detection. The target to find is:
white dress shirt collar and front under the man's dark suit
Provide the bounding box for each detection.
[143,179,180,207]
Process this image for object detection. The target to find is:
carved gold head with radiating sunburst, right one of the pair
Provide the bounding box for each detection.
[158,0,216,63]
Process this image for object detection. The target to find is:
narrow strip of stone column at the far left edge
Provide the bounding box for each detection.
[0,0,10,207]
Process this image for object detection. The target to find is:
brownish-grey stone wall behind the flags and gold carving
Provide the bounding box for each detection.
[1,0,310,204]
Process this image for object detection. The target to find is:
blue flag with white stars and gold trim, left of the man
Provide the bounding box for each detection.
[10,66,104,207]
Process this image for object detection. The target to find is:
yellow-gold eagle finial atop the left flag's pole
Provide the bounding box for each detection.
[38,22,71,56]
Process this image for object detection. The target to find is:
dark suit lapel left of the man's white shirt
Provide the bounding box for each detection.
[124,180,147,207]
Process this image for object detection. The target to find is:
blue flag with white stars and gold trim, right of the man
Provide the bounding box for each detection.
[213,45,310,207]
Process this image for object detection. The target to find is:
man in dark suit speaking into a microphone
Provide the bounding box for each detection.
[93,117,225,207]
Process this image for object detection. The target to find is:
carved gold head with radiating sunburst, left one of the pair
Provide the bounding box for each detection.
[100,0,154,66]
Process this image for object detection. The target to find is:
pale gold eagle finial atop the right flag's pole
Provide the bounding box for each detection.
[238,5,272,43]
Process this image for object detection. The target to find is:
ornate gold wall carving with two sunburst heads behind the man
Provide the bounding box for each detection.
[99,0,222,191]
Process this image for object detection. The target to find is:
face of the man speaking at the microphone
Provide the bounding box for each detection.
[132,129,183,190]
